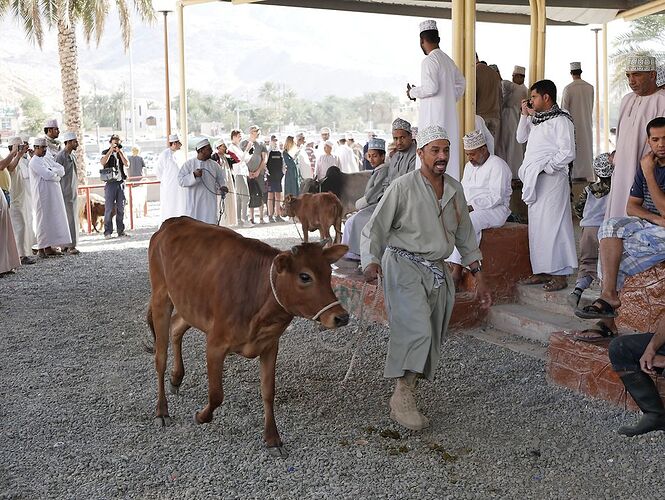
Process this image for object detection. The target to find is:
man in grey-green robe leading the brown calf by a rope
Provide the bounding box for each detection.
[361,125,492,430]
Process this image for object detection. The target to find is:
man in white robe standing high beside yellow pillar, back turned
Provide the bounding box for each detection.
[406,19,466,179]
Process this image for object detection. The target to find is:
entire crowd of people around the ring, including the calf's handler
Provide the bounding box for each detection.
[0,20,665,442]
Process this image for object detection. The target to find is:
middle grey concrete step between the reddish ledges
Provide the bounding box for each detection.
[487,304,594,344]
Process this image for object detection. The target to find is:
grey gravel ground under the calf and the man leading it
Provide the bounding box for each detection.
[0,219,665,499]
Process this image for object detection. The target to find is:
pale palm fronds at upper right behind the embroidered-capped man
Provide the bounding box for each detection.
[611,14,665,96]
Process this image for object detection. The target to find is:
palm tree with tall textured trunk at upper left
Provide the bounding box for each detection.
[0,0,155,181]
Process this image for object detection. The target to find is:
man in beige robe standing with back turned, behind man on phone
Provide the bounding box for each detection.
[561,62,593,181]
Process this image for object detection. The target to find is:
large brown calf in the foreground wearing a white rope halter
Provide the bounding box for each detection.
[147,217,349,456]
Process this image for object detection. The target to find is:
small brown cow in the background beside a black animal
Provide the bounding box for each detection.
[282,193,343,243]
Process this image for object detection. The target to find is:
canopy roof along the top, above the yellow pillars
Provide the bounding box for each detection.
[218,0,665,26]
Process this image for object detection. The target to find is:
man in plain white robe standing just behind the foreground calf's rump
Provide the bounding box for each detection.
[155,134,185,222]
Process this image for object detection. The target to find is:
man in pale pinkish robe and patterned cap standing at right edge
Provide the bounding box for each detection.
[605,55,665,219]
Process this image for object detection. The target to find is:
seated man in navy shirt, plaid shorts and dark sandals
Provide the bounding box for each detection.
[575,116,665,342]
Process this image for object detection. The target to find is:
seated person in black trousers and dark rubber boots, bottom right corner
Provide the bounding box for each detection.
[609,317,665,437]
